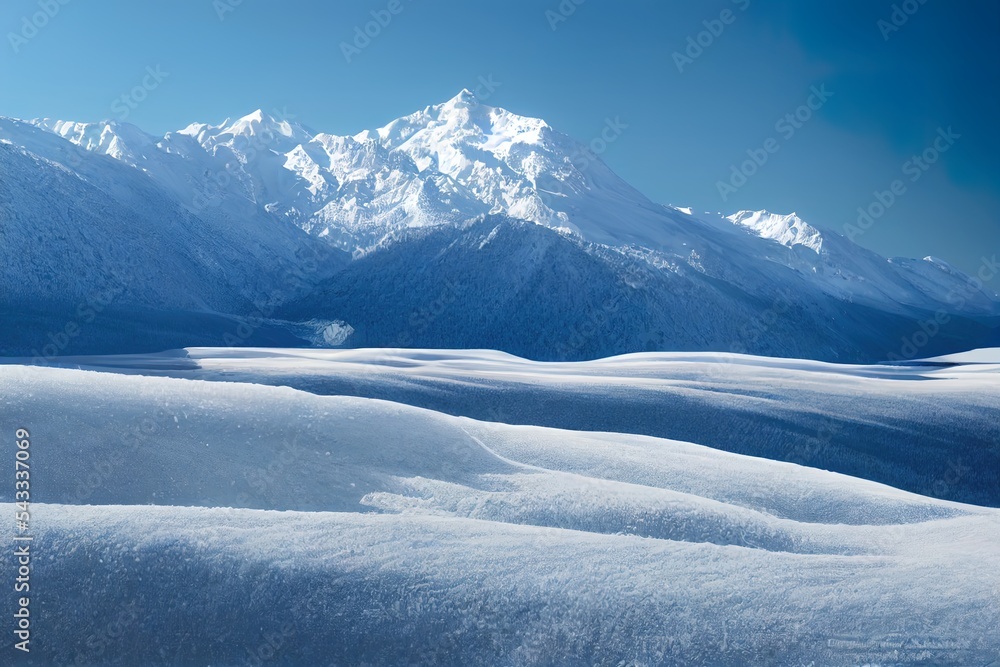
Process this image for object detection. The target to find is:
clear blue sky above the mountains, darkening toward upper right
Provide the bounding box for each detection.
[0,0,1000,271]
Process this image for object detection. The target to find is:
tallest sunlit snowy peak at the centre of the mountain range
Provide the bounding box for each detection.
[340,90,672,247]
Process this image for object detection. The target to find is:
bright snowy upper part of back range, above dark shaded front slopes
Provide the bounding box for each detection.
[9,90,1000,324]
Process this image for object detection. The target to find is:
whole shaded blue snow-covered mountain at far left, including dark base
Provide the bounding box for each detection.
[0,119,346,357]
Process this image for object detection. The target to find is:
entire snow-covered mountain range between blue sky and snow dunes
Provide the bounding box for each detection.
[0,90,1000,362]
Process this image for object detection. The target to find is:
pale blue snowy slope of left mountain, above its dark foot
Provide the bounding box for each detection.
[0,118,338,314]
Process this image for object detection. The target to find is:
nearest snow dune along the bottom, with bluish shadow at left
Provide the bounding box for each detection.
[21,506,998,665]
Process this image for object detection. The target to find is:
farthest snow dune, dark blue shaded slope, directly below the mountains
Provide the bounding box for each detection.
[45,348,1000,507]
